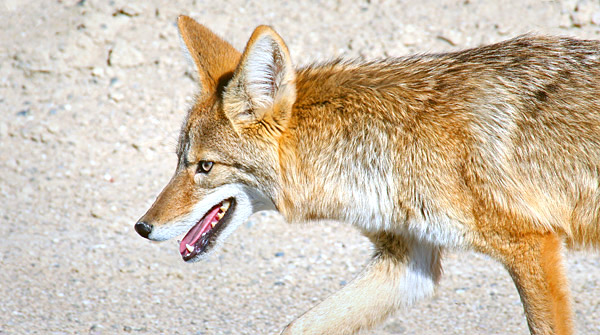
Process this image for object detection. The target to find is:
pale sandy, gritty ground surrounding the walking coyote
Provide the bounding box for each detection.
[0,0,600,335]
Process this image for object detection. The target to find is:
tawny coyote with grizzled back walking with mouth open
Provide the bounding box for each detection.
[135,16,600,334]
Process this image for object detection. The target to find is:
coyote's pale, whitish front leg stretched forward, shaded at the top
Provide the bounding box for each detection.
[282,233,441,335]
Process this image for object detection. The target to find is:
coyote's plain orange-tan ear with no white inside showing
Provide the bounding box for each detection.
[177,15,241,94]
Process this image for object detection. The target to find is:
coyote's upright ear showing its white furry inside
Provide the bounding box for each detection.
[224,26,296,128]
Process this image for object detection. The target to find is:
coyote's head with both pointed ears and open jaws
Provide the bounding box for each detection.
[135,16,296,261]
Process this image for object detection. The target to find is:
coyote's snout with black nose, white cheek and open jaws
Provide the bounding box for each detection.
[135,168,273,262]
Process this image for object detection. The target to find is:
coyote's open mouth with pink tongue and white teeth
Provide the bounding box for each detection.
[179,198,235,262]
